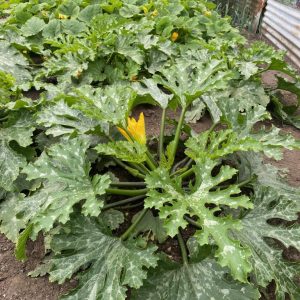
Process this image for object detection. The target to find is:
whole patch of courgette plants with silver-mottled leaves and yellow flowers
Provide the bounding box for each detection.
[0,0,300,300]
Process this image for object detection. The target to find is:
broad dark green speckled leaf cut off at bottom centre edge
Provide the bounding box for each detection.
[132,259,259,300]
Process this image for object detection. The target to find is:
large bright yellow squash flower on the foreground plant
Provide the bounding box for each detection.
[118,112,146,145]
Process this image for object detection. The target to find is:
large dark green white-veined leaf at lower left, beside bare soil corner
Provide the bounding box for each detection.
[37,216,158,300]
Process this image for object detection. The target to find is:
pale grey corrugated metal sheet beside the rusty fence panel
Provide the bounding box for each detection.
[262,0,300,68]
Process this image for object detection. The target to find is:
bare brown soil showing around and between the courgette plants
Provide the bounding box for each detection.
[0,56,300,300]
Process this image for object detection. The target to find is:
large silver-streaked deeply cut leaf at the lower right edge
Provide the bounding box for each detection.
[236,187,300,299]
